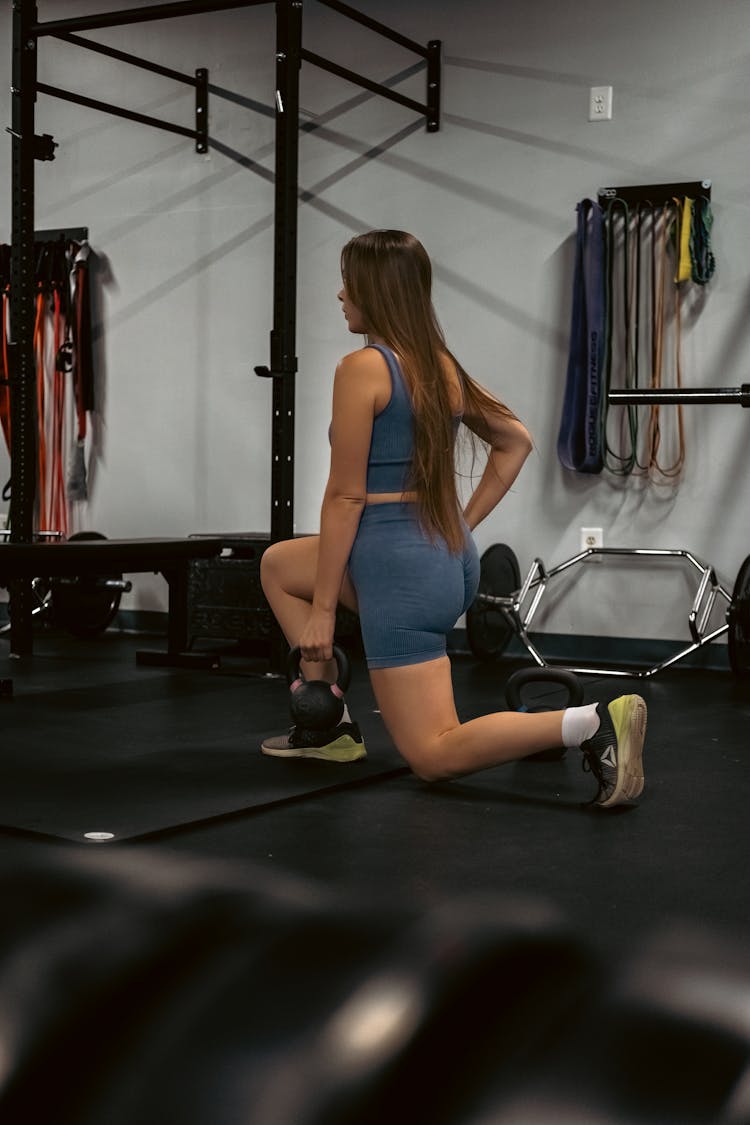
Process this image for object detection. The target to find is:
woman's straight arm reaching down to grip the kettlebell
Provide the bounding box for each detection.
[300,349,381,660]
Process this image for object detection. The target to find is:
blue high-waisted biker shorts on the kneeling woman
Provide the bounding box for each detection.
[349,501,479,668]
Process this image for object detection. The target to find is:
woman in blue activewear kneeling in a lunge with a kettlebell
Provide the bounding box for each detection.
[261,231,647,807]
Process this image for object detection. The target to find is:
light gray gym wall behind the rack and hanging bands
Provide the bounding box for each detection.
[0,0,750,638]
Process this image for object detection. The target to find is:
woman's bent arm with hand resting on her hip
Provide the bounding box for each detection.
[463,400,533,531]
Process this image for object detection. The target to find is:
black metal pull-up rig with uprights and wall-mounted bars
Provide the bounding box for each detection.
[9,0,441,655]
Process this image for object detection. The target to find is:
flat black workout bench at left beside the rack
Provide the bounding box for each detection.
[0,536,224,667]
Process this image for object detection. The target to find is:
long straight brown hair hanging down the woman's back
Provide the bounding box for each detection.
[341,231,515,551]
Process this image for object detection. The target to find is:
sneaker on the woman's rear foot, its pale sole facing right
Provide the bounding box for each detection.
[580,695,647,809]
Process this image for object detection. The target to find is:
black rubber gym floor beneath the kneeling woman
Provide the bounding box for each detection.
[0,632,750,951]
